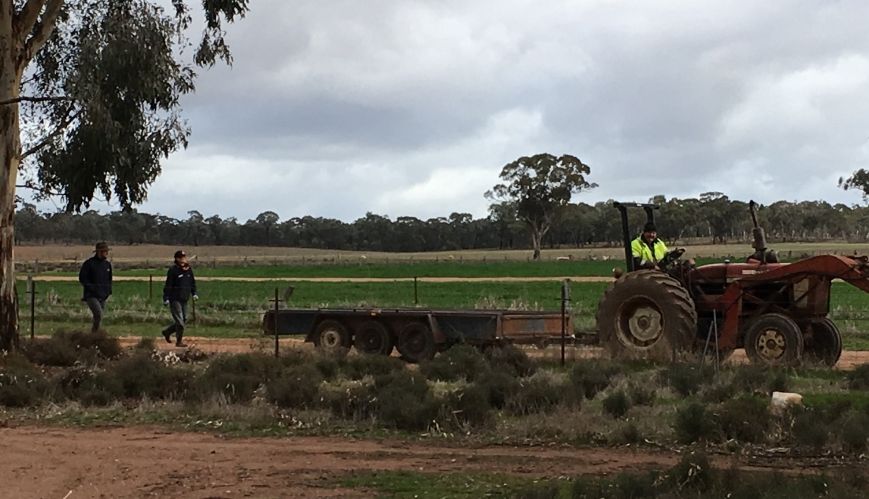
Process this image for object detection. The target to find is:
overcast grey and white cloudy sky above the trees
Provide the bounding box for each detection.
[44,0,869,221]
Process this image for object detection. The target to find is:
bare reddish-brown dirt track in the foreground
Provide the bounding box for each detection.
[0,427,848,499]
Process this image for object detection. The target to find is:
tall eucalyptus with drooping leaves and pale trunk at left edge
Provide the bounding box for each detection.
[0,0,249,349]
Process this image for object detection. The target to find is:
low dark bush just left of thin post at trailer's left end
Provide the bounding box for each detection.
[197,353,283,402]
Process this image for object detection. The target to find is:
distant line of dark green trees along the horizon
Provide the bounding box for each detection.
[15,193,869,252]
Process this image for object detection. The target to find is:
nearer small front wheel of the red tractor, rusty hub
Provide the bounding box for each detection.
[745,314,803,366]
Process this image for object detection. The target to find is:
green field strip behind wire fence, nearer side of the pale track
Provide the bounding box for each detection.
[21,281,869,349]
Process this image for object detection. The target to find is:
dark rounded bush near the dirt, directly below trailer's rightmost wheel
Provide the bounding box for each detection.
[374,370,438,430]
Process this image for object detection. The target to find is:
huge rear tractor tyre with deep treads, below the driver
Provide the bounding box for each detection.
[597,270,697,361]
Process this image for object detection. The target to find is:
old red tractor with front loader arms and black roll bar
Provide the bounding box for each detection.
[597,201,869,366]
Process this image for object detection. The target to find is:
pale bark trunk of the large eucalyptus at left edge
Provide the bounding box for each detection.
[0,8,21,350]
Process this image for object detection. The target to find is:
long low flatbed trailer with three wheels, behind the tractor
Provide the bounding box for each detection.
[262,308,573,362]
